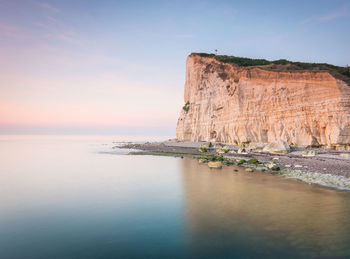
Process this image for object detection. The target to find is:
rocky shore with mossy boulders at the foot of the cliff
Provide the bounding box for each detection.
[118,140,350,190]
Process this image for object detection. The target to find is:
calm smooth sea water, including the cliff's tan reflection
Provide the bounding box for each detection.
[0,136,350,259]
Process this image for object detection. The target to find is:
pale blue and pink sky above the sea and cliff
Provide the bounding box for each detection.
[0,0,350,136]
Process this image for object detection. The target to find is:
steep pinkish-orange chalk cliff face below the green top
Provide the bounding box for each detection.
[176,54,350,147]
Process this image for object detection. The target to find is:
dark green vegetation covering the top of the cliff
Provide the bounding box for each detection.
[191,53,350,85]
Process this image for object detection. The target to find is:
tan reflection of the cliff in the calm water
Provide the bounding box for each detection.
[181,159,350,258]
